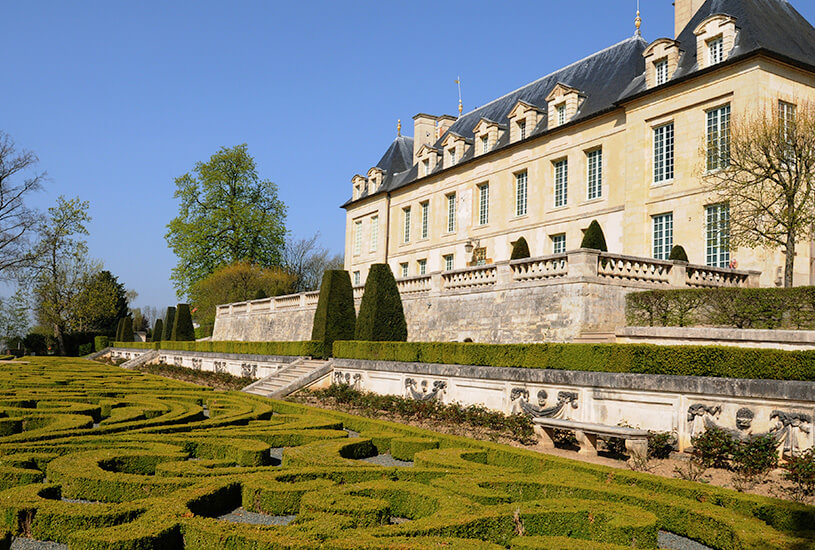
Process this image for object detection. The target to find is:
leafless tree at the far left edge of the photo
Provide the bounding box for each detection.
[0,131,45,279]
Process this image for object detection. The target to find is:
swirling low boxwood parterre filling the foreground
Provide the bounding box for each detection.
[0,358,815,550]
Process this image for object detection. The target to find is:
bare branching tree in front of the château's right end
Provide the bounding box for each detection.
[703,101,815,286]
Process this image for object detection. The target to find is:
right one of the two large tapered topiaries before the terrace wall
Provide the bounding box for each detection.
[355,264,407,342]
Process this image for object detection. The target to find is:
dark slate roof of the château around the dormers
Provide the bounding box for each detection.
[343,0,815,207]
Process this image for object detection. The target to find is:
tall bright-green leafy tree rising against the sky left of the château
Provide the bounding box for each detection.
[165,144,286,297]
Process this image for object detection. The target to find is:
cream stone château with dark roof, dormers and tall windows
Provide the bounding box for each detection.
[343,0,815,292]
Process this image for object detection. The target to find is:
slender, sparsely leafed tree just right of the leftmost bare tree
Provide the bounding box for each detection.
[34,196,94,355]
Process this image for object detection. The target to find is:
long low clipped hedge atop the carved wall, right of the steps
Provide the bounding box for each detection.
[334,341,815,381]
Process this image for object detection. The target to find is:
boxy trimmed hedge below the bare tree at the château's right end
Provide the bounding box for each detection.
[626,286,815,329]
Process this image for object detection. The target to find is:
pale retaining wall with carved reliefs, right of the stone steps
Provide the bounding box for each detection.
[334,359,815,451]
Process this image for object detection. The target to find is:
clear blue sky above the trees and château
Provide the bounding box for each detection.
[6,0,815,307]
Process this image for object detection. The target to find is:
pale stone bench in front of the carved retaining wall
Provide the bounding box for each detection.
[532,418,648,458]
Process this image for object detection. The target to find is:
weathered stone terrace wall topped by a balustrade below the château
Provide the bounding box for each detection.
[212,250,758,343]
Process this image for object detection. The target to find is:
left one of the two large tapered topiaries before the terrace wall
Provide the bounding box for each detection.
[311,269,357,358]
